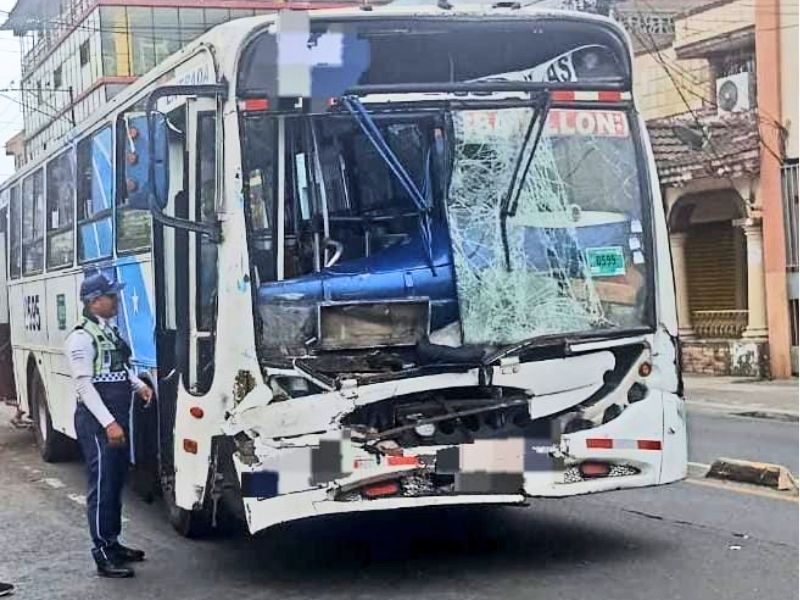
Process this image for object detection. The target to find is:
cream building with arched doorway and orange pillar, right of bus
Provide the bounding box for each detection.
[618,0,798,377]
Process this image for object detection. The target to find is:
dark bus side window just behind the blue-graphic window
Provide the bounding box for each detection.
[47,150,75,269]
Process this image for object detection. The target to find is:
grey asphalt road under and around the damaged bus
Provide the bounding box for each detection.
[0,408,798,600]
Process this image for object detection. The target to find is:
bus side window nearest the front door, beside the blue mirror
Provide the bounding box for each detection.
[116,116,150,253]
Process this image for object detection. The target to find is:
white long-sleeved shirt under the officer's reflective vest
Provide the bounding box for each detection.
[65,317,146,427]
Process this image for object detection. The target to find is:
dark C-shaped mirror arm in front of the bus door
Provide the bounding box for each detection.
[145,83,228,243]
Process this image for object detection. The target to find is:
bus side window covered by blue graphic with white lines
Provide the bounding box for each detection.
[77,127,114,262]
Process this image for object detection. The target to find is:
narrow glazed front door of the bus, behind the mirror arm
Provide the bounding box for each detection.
[154,97,221,395]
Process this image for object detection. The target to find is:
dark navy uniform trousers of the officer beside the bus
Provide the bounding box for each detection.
[75,381,132,560]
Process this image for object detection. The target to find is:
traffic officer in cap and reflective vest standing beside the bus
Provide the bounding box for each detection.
[66,272,152,577]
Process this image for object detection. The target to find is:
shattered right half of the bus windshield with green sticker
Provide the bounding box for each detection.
[447,108,647,344]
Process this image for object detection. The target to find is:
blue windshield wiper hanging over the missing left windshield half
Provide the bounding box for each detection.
[342,96,434,271]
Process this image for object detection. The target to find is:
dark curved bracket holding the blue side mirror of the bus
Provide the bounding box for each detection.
[146,83,228,243]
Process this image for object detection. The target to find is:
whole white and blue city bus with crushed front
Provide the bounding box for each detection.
[0,2,687,536]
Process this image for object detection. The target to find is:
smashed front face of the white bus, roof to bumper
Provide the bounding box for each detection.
[214,10,686,531]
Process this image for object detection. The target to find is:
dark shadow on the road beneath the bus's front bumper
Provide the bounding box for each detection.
[202,507,670,592]
